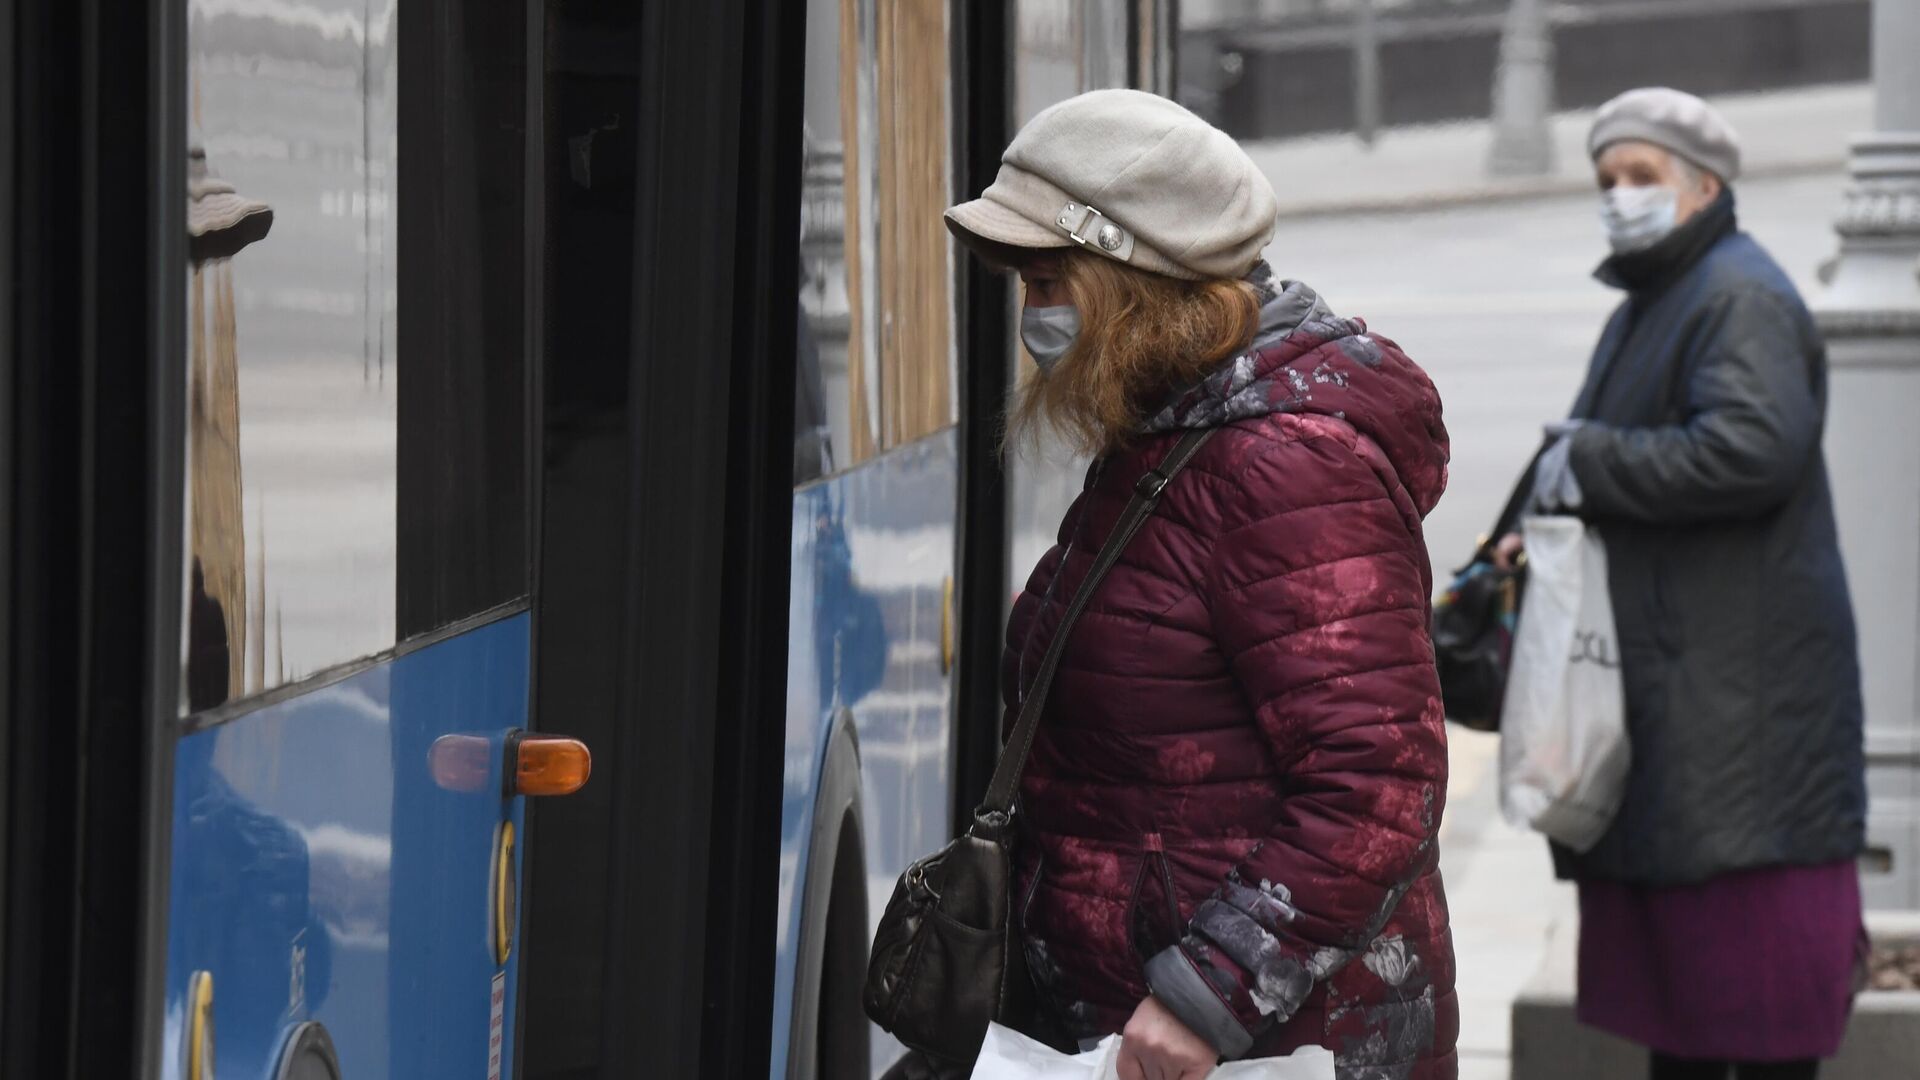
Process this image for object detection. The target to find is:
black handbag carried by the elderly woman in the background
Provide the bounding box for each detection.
[1432,455,1538,732]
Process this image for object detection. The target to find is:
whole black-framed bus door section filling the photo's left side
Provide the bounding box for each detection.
[13,0,804,1080]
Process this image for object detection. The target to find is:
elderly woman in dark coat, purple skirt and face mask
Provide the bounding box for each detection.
[1500,88,1866,1080]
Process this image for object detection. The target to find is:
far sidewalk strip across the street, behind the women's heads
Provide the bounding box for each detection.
[1244,83,1872,217]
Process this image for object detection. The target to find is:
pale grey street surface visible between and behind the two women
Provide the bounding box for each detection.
[1267,171,1843,1080]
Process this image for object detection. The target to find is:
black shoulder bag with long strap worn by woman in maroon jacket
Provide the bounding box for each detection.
[862,429,1213,1061]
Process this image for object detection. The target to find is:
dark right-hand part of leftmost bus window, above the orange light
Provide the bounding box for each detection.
[396,0,538,640]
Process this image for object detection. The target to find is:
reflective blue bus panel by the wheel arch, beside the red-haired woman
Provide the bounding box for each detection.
[772,429,958,1080]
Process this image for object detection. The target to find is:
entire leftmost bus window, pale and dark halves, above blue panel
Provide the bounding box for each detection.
[182,4,528,713]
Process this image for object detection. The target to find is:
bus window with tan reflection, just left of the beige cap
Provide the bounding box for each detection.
[793,0,958,484]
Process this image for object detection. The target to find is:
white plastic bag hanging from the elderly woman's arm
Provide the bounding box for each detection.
[1500,517,1632,851]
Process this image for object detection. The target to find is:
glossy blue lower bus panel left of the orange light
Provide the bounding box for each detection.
[163,613,530,1080]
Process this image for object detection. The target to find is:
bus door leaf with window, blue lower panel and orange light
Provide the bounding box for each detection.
[161,0,589,1080]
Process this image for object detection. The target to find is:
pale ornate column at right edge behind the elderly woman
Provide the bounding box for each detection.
[1816,0,1920,909]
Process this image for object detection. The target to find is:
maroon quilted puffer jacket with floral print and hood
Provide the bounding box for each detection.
[1004,274,1459,1080]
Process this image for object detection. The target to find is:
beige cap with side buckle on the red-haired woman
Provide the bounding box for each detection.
[947,90,1279,281]
